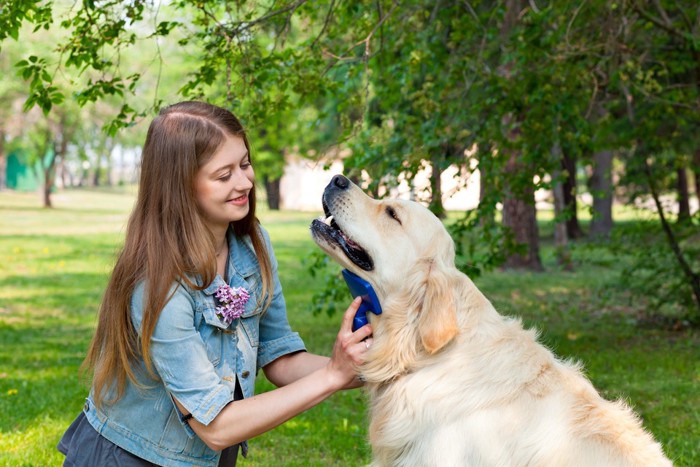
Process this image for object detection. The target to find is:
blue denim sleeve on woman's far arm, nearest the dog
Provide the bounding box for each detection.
[257,229,306,368]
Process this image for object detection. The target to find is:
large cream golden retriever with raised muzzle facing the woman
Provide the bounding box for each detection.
[311,175,672,467]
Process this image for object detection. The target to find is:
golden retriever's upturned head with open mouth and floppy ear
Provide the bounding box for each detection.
[311,175,457,362]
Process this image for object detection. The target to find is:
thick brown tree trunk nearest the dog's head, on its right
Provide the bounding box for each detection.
[503,150,544,271]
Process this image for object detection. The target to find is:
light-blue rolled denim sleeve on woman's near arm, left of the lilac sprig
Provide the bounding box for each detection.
[132,284,233,425]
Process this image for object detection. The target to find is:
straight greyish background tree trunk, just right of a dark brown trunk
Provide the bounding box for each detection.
[588,150,613,237]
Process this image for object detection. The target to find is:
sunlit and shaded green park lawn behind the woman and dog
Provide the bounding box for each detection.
[0,189,700,466]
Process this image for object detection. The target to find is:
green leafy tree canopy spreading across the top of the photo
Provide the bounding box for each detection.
[0,0,700,322]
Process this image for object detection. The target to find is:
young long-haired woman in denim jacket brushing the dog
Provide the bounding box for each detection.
[59,102,372,466]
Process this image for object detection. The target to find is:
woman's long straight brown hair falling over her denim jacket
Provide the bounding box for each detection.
[83,102,272,405]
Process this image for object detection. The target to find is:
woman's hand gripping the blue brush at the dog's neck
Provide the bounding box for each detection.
[327,297,372,389]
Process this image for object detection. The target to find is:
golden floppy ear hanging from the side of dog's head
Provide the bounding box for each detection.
[418,260,459,354]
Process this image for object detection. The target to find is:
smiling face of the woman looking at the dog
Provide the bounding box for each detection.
[194,135,255,233]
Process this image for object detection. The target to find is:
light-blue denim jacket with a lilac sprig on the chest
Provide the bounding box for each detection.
[84,225,305,466]
